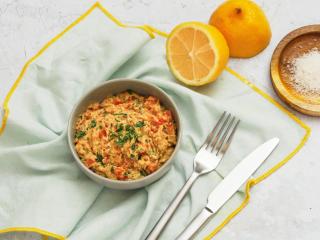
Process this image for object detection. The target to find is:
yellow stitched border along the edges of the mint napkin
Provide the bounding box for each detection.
[0,2,311,240]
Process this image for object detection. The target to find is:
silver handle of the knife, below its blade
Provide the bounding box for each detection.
[176,208,214,240]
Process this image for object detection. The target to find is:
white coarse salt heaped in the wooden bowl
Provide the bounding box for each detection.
[289,48,320,95]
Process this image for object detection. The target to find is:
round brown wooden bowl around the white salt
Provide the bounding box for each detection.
[270,25,320,116]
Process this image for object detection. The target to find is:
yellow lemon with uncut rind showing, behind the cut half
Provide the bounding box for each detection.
[209,0,271,58]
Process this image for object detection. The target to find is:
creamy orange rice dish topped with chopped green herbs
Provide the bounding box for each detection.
[74,90,177,180]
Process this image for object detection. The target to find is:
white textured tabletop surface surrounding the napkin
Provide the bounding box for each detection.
[0,0,320,240]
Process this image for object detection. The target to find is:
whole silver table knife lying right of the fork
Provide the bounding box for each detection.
[176,138,279,240]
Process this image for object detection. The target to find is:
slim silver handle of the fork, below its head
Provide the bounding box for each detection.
[146,171,200,240]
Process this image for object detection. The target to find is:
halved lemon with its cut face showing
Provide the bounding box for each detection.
[167,22,229,86]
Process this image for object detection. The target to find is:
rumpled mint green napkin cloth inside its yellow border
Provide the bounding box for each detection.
[0,4,306,240]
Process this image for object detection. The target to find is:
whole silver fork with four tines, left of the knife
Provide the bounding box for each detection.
[146,112,240,240]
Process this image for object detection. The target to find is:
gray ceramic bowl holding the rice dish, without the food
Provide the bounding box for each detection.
[68,79,181,189]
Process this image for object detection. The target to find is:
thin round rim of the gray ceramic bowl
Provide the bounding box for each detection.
[67,78,182,186]
